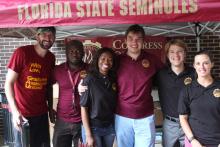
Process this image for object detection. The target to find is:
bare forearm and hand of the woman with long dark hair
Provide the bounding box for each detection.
[81,107,95,147]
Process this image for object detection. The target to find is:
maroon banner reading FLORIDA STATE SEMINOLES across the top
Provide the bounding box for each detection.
[0,0,220,28]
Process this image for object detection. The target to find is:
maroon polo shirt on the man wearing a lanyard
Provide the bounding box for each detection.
[54,63,88,123]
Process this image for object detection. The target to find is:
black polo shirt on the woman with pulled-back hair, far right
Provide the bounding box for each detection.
[178,81,220,145]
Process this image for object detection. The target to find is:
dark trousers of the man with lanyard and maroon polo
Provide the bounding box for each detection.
[53,119,81,147]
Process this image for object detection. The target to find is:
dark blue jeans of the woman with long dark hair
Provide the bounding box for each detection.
[82,125,115,147]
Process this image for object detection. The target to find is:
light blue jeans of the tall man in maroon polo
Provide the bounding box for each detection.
[115,115,155,147]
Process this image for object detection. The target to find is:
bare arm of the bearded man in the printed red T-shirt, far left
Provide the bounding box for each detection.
[5,69,25,130]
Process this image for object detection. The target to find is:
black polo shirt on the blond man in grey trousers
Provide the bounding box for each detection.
[155,66,195,118]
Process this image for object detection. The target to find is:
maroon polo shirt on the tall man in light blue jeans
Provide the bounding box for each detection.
[116,51,162,119]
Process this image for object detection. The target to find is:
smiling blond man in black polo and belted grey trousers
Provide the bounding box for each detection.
[156,39,194,147]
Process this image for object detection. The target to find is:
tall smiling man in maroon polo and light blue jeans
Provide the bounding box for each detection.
[115,25,161,147]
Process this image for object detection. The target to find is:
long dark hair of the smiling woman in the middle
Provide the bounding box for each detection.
[90,47,118,81]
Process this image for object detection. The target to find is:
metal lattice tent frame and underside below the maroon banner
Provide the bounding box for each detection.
[0,22,220,40]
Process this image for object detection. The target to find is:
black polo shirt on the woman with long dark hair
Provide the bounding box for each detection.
[80,74,117,127]
